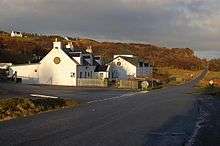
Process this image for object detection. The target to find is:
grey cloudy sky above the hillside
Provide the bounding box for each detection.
[0,0,220,51]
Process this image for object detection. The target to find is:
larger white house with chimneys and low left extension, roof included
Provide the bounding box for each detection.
[11,41,101,86]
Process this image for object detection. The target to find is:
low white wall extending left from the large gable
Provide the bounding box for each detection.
[10,64,40,84]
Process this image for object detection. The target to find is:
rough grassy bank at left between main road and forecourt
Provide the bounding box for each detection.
[0,98,79,121]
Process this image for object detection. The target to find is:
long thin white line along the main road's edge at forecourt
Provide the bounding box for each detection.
[87,91,149,104]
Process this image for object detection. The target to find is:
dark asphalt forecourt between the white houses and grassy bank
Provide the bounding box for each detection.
[0,82,133,102]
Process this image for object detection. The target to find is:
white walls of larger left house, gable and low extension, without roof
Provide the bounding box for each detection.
[11,41,107,86]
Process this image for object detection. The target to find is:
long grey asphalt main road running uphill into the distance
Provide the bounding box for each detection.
[0,72,205,146]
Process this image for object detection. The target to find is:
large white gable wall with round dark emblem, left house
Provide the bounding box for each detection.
[39,46,77,86]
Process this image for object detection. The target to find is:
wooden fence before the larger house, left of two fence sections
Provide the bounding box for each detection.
[77,78,108,87]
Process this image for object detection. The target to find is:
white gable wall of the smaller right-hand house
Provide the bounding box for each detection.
[109,57,137,79]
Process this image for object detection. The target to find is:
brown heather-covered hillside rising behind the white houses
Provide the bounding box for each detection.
[0,31,204,69]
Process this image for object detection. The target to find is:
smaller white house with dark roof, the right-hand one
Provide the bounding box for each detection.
[108,55,153,80]
